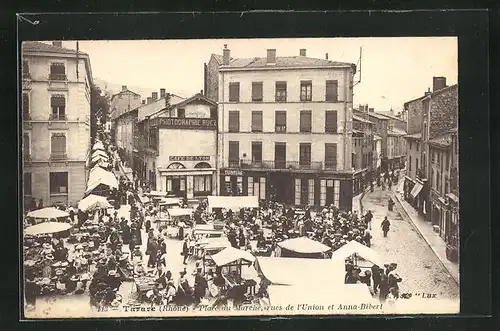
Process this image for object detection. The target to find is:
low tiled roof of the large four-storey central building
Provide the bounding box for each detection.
[221,56,354,68]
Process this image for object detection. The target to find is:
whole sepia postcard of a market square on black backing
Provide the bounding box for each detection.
[19,37,465,319]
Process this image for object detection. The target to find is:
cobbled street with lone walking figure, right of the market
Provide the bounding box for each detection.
[362,187,459,300]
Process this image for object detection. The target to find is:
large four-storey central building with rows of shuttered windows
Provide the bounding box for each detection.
[206,48,356,210]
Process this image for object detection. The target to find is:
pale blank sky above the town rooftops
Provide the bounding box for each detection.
[59,37,458,111]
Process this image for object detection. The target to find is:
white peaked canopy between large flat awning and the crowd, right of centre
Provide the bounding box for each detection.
[276,237,331,259]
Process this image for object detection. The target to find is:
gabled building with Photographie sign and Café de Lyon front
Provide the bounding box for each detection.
[137,94,217,198]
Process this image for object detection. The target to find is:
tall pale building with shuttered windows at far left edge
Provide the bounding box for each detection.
[21,42,93,206]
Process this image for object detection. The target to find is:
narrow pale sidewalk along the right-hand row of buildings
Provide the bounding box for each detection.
[394,193,460,284]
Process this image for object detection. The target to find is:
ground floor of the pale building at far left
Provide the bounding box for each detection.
[23,161,88,207]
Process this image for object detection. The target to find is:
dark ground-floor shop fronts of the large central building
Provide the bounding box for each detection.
[219,169,353,210]
